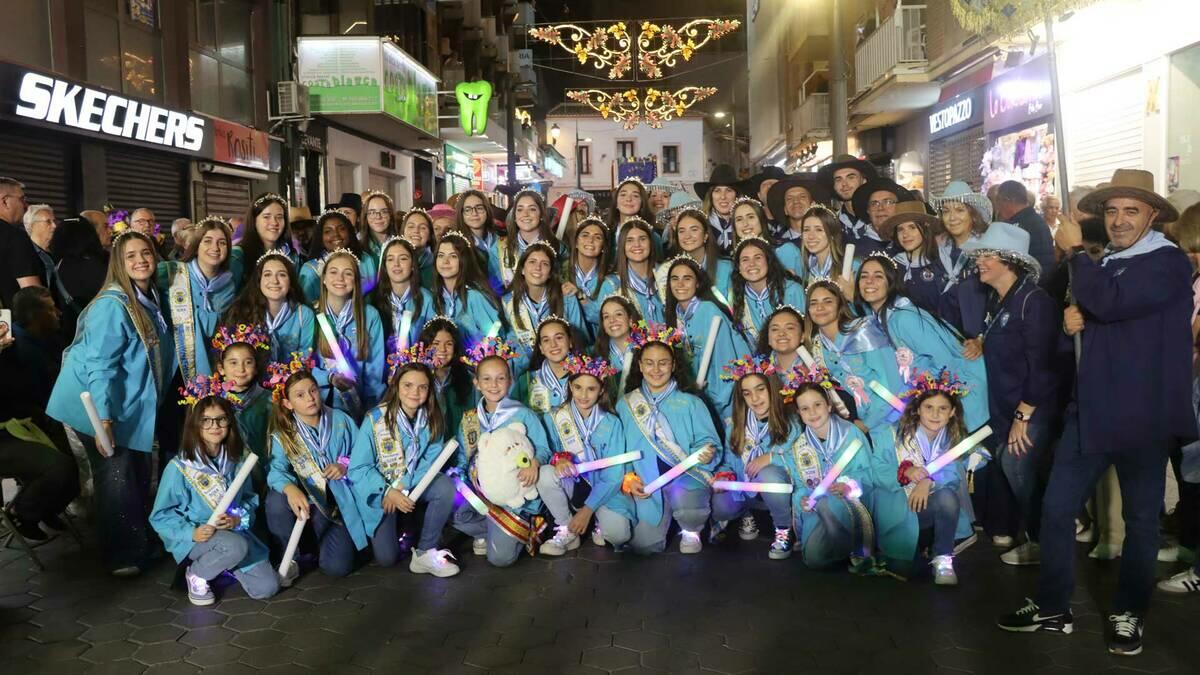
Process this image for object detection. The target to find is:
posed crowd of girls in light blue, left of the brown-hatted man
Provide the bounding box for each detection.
[42,159,1195,638]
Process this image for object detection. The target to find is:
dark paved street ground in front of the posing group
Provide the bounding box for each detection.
[0,526,1200,675]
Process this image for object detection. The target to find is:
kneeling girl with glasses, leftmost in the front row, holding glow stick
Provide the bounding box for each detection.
[150,380,280,605]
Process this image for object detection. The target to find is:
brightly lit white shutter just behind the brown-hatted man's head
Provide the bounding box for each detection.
[1064,71,1146,185]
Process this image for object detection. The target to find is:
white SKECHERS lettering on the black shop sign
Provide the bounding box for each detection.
[17,72,204,153]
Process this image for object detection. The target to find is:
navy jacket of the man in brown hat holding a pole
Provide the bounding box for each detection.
[1075,246,1196,453]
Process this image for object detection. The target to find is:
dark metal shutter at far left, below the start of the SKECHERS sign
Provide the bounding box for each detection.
[0,133,76,217]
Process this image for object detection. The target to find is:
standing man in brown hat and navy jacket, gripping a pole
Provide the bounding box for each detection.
[998,169,1196,656]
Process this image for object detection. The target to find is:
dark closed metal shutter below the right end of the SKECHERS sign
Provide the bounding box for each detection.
[104,145,191,220]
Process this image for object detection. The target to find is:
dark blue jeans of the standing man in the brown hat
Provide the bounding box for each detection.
[1037,414,1166,614]
